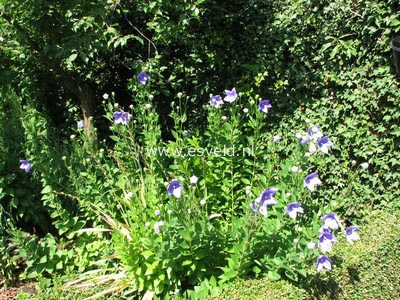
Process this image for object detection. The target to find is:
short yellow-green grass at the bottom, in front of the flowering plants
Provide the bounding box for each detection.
[16,212,400,300]
